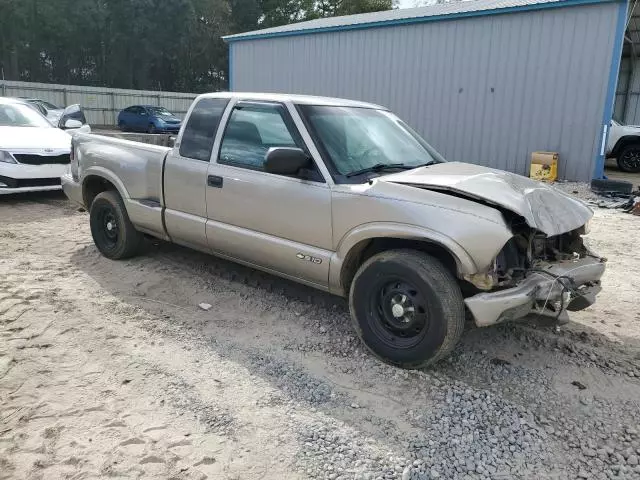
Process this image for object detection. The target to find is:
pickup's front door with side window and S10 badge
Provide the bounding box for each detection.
[206,101,332,287]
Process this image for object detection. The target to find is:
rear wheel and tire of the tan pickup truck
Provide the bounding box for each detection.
[89,190,144,260]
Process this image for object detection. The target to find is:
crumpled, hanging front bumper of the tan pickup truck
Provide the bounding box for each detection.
[465,256,605,327]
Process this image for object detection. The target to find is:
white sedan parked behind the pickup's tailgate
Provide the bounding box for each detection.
[0,97,88,194]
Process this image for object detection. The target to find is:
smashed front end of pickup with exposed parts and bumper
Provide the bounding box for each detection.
[465,217,606,326]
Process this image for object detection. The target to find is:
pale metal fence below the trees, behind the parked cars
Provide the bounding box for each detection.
[0,80,196,125]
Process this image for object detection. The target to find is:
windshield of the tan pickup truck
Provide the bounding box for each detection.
[300,105,442,177]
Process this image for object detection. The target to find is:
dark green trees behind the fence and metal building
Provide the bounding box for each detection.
[0,0,392,92]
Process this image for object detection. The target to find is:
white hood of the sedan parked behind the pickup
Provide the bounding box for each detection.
[0,127,71,153]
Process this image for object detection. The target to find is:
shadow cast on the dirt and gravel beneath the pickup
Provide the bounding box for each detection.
[72,234,640,420]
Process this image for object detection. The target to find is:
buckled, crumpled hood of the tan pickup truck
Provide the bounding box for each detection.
[378,162,593,236]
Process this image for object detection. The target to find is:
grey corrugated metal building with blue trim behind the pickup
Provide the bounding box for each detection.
[225,0,628,181]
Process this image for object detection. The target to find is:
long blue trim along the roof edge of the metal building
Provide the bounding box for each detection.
[222,0,627,44]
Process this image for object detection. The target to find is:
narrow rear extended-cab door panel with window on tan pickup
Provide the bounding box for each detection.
[163,98,229,251]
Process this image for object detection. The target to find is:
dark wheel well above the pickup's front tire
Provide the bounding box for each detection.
[340,237,458,294]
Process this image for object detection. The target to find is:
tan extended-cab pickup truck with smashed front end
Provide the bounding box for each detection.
[63,92,605,368]
